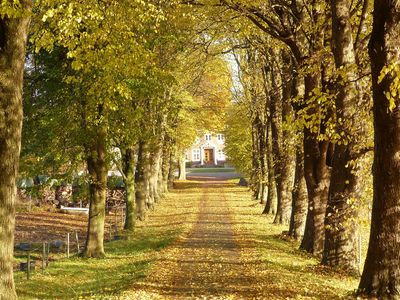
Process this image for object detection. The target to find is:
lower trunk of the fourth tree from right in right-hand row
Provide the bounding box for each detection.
[289,144,308,240]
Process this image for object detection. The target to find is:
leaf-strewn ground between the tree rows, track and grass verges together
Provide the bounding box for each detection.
[16,180,358,299]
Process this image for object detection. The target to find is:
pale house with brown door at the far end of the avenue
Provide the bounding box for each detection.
[185,133,226,167]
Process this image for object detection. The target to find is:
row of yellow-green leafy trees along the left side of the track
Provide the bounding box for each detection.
[0,0,230,299]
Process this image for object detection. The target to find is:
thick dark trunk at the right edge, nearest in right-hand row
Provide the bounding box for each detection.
[359,0,400,299]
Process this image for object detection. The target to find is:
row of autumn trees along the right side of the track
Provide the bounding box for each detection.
[222,0,400,296]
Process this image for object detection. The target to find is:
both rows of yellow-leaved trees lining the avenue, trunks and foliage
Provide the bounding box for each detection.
[0,0,400,299]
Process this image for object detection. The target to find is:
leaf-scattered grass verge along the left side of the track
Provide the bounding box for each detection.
[15,186,201,299]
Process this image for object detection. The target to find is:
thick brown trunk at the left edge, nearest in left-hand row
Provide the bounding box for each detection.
[0,1,31,300]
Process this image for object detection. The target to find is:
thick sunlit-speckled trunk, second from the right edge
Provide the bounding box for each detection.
[322,0,361,274]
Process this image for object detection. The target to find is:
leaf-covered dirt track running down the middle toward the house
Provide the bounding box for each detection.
[126,181,255,299]
